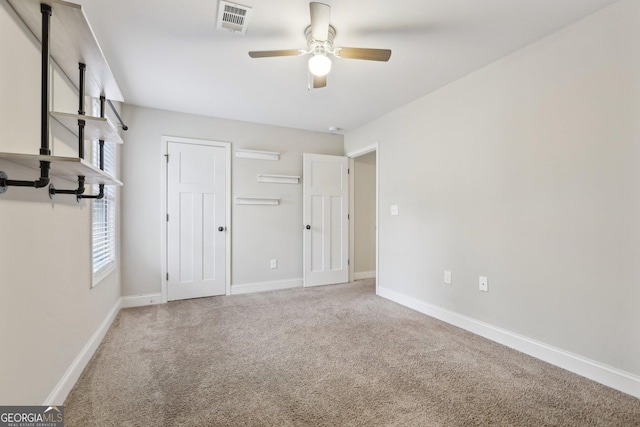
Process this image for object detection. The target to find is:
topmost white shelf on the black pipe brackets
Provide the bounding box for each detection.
[8,0,124,101]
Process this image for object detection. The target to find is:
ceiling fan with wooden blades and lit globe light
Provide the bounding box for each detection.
[249,2,391,89]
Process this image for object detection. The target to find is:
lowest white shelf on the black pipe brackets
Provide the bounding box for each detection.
[0,153,122,185]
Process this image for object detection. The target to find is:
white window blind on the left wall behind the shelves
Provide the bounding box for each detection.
[92,100,117,285]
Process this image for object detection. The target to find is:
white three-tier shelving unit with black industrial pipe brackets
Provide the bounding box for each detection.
[0,0,126,200]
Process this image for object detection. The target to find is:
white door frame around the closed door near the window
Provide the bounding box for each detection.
[160,135,232,303]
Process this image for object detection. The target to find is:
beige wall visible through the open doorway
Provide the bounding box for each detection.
[351,151,376,279]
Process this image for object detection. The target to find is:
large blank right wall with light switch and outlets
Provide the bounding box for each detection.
[345,0,640,376]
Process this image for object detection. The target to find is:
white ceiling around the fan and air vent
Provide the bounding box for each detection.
[72,0,616,132]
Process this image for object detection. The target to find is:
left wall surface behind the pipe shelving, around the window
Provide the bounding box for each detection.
[0,2,120,405]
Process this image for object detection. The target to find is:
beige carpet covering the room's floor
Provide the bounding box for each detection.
[65,280,640,427]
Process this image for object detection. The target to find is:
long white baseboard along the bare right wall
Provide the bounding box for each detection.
[378,287,640,398]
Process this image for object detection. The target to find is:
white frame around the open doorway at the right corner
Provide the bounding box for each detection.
[346,142,380,294]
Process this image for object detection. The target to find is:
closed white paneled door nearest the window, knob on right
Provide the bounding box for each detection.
[167,141,227,301]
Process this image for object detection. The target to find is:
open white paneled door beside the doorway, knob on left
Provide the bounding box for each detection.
[303,154,349,286]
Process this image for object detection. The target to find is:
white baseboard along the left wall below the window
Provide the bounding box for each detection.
[42,298,121,406]
